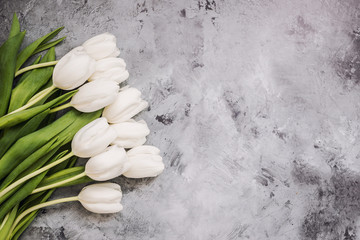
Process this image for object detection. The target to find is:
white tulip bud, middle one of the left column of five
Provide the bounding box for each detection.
[71,117,116,158]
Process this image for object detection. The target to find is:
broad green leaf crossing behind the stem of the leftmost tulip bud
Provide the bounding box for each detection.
[8,48,55,112]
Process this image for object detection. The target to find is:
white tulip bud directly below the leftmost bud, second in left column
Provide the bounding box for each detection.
[70,81,119,112]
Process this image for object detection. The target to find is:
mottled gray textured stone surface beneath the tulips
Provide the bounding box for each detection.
[0,0,360,240]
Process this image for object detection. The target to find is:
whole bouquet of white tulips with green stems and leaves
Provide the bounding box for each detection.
[0,15,164,240]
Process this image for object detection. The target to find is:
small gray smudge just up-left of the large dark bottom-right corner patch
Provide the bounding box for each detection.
[291,160,321,185]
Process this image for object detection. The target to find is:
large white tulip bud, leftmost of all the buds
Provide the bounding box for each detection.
[53,47,96,90]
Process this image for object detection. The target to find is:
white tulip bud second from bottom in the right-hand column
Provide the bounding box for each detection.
[110,119,150,148]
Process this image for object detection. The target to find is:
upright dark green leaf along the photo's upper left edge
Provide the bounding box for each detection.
[0,32,25,117]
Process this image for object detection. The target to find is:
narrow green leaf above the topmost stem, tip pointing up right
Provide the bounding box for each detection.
[15,27,64,71]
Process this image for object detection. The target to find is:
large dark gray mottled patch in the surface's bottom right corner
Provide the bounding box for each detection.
[302,166,360,240]
